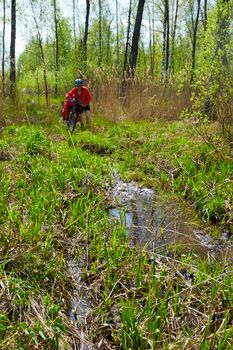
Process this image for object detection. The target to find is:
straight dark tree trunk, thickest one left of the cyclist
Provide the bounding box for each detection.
[10,0,16,98]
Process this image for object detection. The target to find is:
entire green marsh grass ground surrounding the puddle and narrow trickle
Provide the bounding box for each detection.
[0,119,233,350]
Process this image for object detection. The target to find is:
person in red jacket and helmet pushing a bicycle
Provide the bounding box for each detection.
[63,78,91,128]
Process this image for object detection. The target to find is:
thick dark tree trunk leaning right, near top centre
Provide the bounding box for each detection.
[129,0,145,77]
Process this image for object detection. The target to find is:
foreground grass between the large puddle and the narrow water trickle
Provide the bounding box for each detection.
[84,227,233,349]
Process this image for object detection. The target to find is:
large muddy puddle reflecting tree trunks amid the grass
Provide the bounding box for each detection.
[109,179,233,256]
